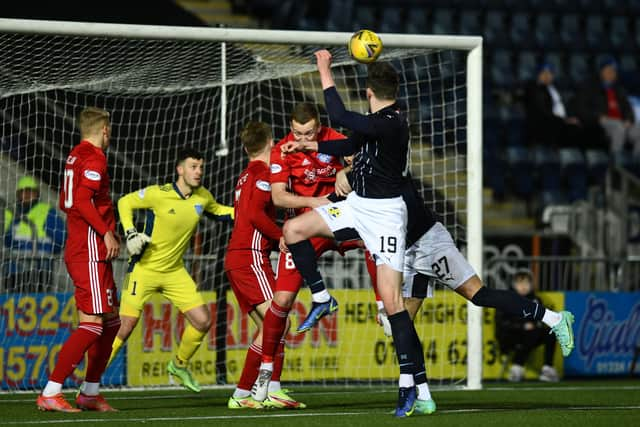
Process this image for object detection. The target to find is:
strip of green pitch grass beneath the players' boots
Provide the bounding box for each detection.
[0,379,640,427]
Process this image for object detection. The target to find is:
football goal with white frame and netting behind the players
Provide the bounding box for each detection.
[0,20,480,390]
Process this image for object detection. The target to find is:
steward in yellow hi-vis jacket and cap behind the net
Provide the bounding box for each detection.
[4,176,65,291]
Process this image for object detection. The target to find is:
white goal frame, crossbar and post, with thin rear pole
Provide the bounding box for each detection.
[0,19,483,390]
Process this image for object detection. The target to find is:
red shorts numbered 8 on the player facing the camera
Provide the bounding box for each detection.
[276,237,362,292]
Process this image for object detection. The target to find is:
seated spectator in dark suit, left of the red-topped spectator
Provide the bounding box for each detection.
[524,62,582,148]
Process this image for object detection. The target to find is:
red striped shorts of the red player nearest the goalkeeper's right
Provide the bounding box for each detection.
[226,261,276,313]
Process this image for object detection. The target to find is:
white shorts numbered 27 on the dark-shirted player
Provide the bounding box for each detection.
[402,222,476,298]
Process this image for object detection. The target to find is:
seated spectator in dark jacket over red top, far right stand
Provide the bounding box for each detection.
[576,57,640,159]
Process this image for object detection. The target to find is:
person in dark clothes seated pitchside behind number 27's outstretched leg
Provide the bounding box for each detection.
[496,269,559,382]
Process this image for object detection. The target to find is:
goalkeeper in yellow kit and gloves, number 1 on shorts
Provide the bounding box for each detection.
[110,149,233,393]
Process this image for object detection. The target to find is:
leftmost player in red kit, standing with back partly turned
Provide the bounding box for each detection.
[36,107,120,412]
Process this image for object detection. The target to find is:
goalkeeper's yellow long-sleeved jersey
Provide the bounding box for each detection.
[118,183,234,272]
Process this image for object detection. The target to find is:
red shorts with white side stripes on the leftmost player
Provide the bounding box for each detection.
[67,261,120,314]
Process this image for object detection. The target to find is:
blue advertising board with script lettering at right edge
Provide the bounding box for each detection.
[564,292,640,376]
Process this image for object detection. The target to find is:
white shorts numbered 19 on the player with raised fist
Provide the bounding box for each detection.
[315,192,407,272]
